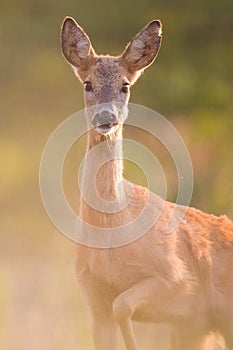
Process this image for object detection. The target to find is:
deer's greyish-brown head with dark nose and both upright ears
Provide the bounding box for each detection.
[61,17,162,135]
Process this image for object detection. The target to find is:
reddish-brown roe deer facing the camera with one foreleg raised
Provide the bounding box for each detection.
[61,17,233,350]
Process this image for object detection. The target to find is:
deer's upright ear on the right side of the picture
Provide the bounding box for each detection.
[121,20,162,73]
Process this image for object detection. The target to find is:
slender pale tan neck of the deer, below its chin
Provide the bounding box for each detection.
[81,126,125,212]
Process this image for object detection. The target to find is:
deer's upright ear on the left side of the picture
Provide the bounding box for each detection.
[61,17,95,70]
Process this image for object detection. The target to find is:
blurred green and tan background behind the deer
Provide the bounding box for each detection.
[0,0,233,350]
